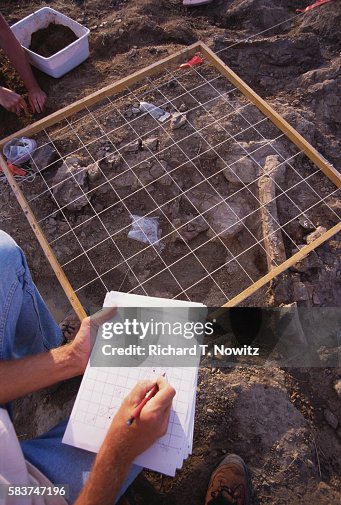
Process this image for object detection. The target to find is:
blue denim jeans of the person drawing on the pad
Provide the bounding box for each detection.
[0,230,142,503]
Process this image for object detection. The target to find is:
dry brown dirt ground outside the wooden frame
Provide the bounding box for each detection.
[0,0,341,505]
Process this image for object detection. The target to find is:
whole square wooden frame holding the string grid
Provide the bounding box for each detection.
[0,41,341,319]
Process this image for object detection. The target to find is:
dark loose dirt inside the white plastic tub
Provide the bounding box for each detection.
[30,23,78,58]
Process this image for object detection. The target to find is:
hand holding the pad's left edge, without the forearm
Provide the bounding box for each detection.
[67,307,117,375]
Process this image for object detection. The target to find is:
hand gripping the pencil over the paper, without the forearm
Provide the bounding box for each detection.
[104,377,175,462]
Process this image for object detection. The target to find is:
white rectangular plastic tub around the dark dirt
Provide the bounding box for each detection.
[11,7,90,78]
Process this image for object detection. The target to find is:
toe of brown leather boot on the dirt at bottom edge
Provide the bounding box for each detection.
[205,454,251,505]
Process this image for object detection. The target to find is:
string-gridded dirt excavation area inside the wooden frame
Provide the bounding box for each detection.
[11,48,340,305]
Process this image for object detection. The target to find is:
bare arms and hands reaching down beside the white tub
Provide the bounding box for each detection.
[0,14,46,112]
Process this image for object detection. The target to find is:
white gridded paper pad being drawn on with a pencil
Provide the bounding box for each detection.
[63,292,204,476]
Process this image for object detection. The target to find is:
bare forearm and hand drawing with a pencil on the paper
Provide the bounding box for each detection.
[75,377,175,505]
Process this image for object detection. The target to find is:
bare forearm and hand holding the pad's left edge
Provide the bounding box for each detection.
[0,308,116,405]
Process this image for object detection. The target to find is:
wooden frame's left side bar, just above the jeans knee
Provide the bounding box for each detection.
[0,154,87,320]
